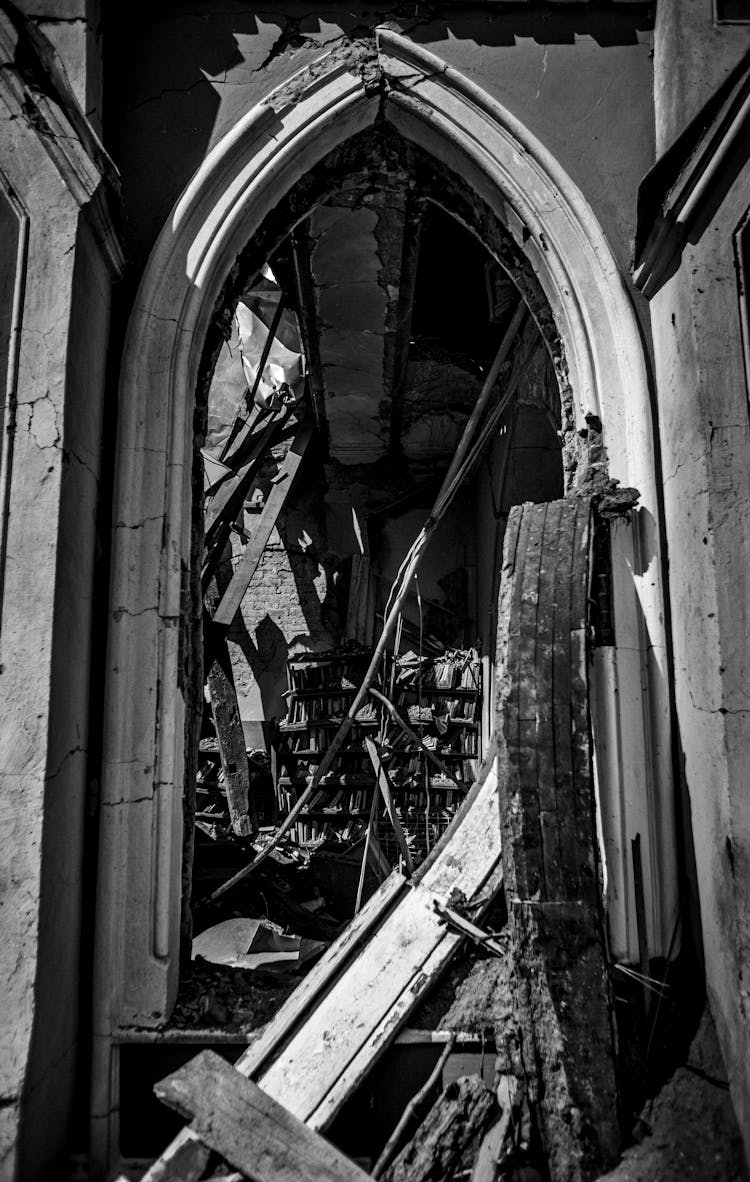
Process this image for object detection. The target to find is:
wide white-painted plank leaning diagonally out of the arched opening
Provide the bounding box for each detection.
[246,761,502,1128]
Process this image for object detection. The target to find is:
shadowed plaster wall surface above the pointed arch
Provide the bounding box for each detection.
[104,0,653,288]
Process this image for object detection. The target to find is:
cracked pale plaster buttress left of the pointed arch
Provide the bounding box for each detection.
[0,34,114,1180]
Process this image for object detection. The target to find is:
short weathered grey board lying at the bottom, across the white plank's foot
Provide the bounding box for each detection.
[154,1051,367,1182]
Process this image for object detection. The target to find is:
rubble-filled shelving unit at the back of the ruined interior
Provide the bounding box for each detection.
[278,647,482,865]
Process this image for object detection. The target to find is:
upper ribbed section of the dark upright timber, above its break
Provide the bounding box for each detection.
[497,498,593,901]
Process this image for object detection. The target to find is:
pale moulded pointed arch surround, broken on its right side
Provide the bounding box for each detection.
[93,28,674,1167]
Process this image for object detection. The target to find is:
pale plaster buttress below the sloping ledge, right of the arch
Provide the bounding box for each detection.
[651,117,750,1163]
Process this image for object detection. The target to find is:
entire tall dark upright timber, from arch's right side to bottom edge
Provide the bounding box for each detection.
[497,496,617,1177]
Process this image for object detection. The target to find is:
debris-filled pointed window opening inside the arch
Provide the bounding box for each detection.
[172,191,562,1030]
